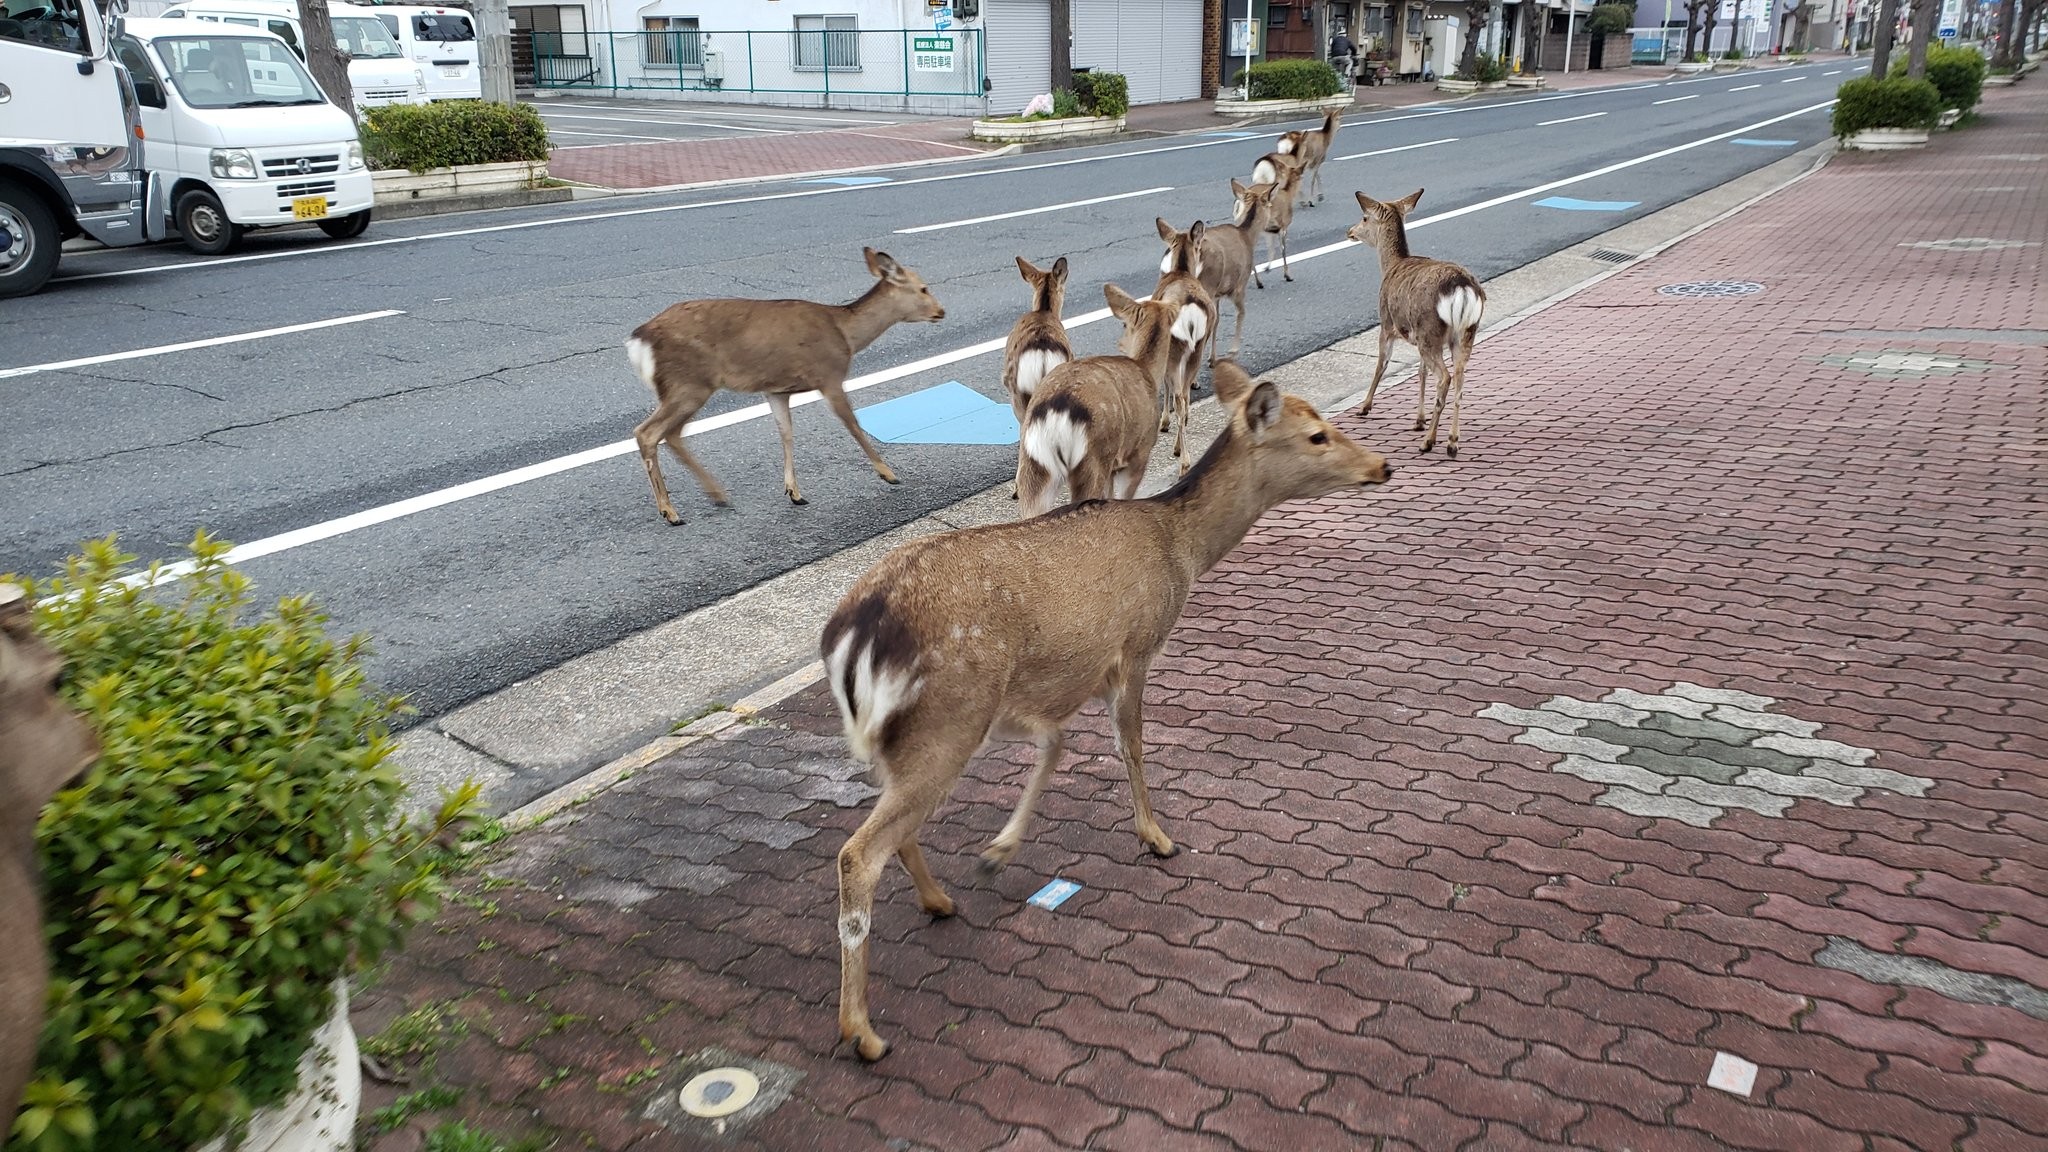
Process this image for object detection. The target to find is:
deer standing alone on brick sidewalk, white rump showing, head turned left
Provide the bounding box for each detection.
[1346,189,1487,459]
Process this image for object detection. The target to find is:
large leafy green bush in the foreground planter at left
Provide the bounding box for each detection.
[6,533,475,1152]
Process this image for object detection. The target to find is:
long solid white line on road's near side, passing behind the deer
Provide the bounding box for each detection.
[88,100,1835,584]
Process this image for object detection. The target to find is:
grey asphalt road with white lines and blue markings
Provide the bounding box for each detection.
[0,59,1855,715]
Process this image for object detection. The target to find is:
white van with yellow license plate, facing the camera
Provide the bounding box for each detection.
[113,18,375,256]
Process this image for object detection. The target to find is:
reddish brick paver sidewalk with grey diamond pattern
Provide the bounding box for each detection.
[358,88,2048,1152]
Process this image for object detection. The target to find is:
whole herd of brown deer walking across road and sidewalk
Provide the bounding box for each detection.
[627,113,1485,1060]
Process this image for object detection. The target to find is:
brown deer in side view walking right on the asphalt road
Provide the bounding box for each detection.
[627,248,946,525]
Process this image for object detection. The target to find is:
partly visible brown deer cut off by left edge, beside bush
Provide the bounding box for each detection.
[0,584,100,1129]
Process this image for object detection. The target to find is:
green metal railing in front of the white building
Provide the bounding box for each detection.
[526,26,983,102]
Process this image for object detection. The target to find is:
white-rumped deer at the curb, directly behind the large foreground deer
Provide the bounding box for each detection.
[1018,285,1186,517]
